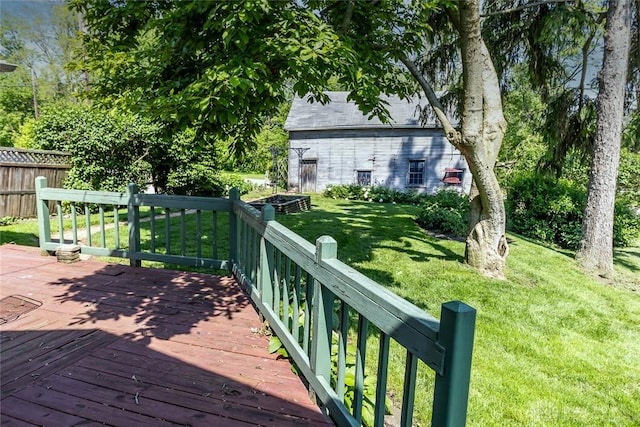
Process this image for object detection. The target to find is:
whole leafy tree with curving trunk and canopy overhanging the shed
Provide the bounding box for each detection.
[73,0,520,277]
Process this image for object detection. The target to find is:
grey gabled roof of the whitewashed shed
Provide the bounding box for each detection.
[284,92,440,131]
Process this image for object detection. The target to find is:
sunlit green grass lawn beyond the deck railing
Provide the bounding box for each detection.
[0,195,640,426]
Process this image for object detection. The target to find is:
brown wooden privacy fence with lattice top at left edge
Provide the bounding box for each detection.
[0,147,71,218]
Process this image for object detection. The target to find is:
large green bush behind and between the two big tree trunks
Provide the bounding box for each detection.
[505,174,640,249]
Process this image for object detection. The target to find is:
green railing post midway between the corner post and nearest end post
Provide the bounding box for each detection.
[309,236,338,386]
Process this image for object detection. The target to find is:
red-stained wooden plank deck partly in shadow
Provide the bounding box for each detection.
[0,245,331,427]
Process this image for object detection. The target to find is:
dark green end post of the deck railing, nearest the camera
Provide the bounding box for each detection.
[431,301,476,427]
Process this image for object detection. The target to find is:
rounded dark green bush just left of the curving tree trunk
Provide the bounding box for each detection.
[416,190,469,236]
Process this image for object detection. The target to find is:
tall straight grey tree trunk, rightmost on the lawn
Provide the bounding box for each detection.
[576,0,632,276]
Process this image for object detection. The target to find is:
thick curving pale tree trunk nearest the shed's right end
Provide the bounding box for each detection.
[455,0,509,278]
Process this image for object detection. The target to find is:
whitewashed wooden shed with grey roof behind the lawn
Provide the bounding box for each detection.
[285,92,471,193]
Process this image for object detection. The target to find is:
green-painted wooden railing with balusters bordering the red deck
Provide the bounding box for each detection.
[36,177,476,427]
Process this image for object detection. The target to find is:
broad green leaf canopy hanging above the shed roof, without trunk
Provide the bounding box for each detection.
[71,0,428,157]
